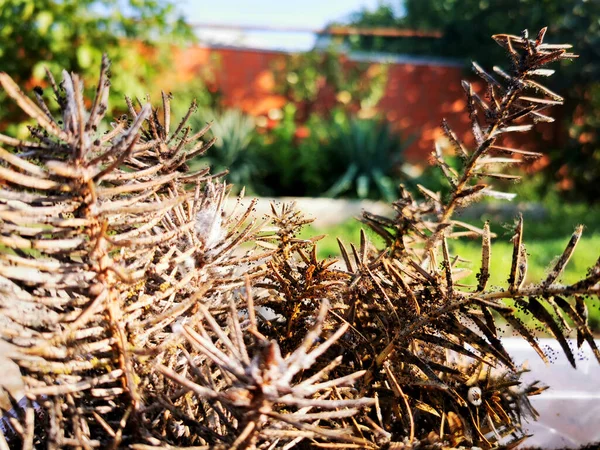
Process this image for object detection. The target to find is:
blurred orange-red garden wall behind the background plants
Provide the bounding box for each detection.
[170,47,548,162]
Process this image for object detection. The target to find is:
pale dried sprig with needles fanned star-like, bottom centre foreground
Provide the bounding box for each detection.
[151,301,373,449]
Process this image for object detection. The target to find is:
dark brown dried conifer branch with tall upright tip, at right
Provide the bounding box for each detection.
[352,30,600,448]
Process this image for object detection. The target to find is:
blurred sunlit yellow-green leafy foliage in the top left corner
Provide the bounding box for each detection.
[0,0,195,136]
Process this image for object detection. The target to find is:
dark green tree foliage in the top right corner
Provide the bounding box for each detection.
[342,0,600,201]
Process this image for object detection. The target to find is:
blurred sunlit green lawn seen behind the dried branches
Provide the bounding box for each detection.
[299,205,600,333]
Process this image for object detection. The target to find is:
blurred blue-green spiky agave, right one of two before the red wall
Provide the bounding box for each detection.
[324,118,410,201]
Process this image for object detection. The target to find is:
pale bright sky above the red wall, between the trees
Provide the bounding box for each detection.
[178,0,399,50]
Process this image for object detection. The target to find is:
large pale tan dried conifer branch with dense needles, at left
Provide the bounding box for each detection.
[0,54,268,448]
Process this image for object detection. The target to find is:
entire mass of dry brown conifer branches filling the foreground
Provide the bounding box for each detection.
[0,29,600,449]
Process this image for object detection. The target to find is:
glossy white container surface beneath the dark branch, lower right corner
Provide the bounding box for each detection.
[502,338,600,450]
